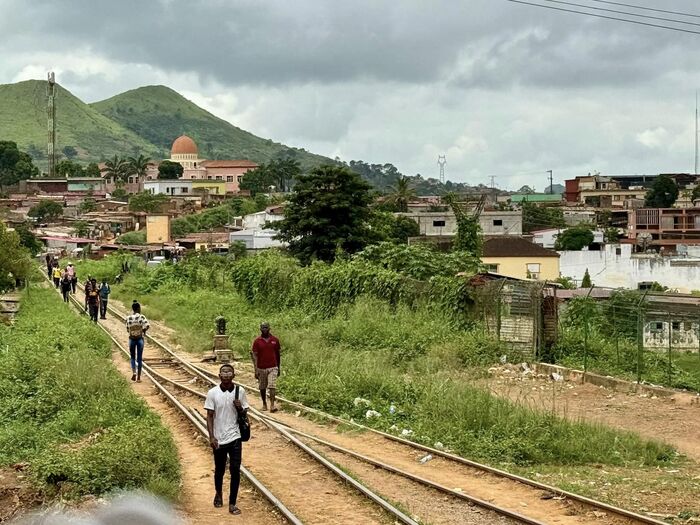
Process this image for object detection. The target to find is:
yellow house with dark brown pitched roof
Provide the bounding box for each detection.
[481,235,560,281]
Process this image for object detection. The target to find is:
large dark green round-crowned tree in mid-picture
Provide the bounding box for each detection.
[270,165,372,264]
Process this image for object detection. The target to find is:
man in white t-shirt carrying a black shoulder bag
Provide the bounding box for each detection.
[204,364,250,514]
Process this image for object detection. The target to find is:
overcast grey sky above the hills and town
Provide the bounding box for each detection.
[0,0,700,190]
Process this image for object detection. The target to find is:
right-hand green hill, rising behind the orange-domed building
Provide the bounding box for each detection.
[91,86,330,167]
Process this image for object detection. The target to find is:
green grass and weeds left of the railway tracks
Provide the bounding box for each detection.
[0,286,180,499]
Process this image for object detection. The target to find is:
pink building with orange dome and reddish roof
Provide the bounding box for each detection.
[168,135,258,194]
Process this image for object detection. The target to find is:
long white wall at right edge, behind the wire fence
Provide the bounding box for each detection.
[559,244,700,293]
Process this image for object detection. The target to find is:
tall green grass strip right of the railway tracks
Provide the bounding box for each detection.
[101,262,674,466]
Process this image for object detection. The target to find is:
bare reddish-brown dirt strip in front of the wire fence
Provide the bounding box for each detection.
[483,367,700,462]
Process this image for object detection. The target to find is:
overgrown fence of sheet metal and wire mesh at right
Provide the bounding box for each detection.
[473,279,700,390]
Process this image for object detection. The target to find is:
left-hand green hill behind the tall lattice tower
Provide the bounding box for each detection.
[0,80,158,167]
